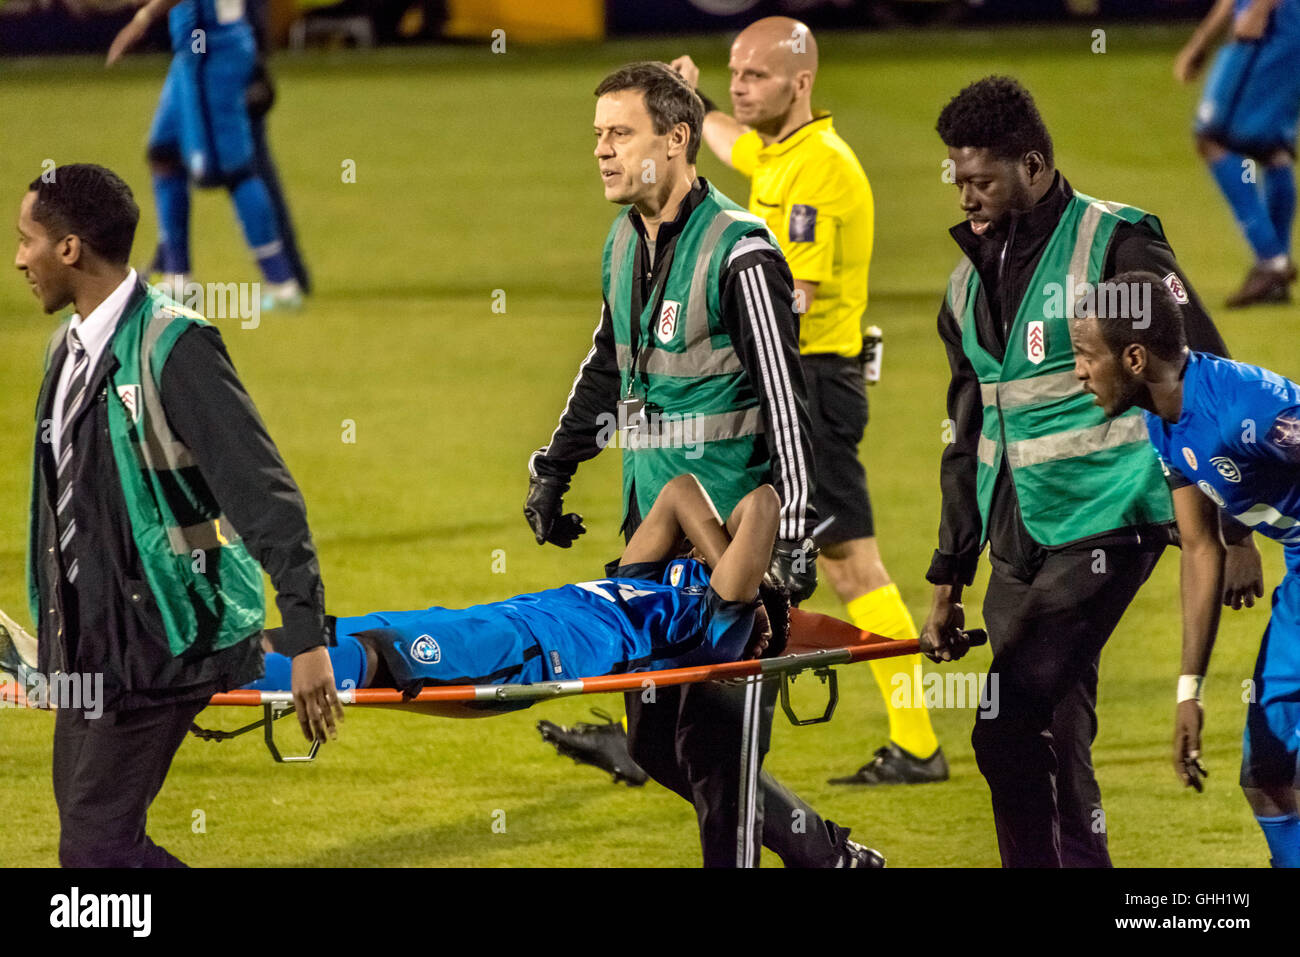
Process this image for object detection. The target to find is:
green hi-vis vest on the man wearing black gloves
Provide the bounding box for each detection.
[602,185,780,519]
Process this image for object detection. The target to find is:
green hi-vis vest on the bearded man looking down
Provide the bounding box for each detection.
[948,192,1174,546]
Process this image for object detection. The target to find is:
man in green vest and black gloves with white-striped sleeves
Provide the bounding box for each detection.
[524,62,878,867]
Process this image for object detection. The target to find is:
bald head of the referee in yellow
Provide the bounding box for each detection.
[731,17,816,139]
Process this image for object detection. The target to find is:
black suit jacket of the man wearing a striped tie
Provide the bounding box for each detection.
[33,276,326,711]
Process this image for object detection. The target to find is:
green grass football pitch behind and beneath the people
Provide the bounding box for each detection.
[0,27,1300,866]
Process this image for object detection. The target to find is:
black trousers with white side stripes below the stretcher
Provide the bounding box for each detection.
[625,675,849,867]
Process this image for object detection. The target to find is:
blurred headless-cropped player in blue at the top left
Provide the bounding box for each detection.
[108,0,303,309]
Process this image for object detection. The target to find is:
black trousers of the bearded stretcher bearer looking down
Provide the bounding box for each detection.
[971,547,1161,867]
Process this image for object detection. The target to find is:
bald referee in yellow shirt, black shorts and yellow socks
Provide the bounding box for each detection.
[672,17,948,784]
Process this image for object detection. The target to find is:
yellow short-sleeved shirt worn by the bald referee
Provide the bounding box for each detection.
[731,112,875,356]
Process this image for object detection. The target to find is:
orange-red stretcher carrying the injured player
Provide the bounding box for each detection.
[191,609,988,763]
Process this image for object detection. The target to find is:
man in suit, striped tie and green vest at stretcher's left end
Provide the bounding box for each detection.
[14,164,341,867]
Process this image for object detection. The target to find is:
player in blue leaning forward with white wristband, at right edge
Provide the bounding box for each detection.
[1073,273,1300,867]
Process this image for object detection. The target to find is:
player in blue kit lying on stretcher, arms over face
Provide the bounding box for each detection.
[247,475,789,694]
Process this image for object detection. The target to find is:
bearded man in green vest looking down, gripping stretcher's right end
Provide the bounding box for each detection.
[920,77,1260,867]
